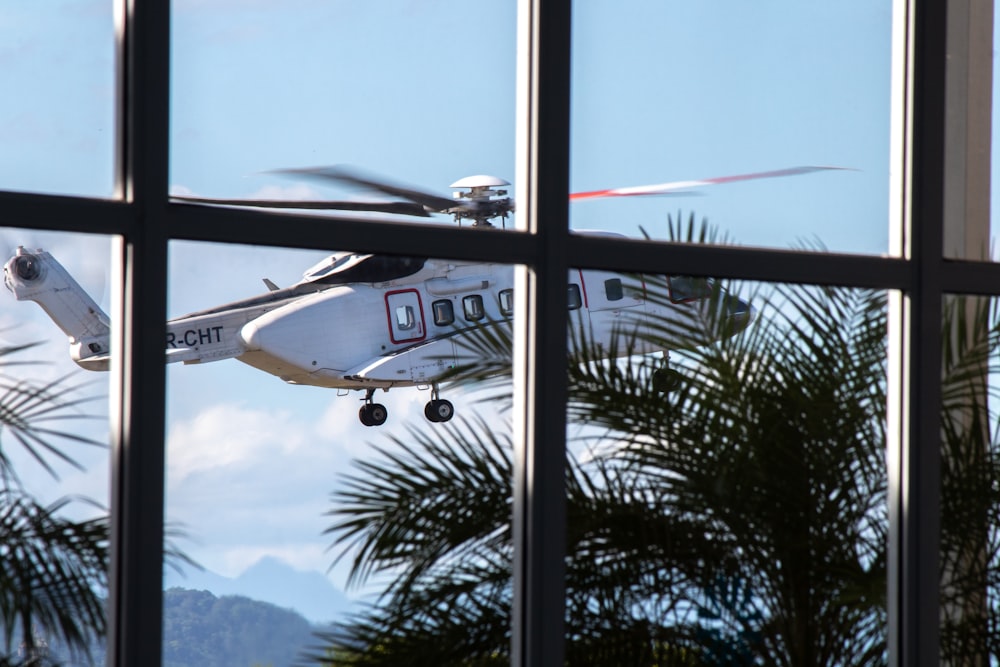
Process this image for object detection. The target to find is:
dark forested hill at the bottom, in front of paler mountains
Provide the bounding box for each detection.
[163,588,317,667]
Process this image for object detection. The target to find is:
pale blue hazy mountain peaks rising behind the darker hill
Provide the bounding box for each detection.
[163,556,356,623]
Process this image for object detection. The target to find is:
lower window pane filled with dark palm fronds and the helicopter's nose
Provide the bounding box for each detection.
[566,270,888,666]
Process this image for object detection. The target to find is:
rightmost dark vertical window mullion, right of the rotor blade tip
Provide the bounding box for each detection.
[890,0,947,667]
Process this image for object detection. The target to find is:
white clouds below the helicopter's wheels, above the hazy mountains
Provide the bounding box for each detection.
[166,380,500,584]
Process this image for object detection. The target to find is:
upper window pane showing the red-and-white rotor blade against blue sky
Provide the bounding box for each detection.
[570,0,898,254]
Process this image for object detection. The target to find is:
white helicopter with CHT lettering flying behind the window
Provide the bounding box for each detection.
[4,167,830,426]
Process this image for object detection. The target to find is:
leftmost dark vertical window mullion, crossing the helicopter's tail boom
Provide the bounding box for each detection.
[108,0,170,667]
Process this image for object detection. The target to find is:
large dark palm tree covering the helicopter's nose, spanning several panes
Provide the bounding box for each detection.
[320,226,1000,666]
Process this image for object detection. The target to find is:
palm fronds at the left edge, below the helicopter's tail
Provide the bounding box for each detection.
[0,345,108,665]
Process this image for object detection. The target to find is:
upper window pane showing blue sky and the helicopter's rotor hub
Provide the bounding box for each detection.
[170,0,516,226]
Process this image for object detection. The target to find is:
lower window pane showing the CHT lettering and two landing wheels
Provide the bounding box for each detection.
[163,242,513,665]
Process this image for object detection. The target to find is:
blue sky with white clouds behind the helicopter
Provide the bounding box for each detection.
[0,0,944,620]
